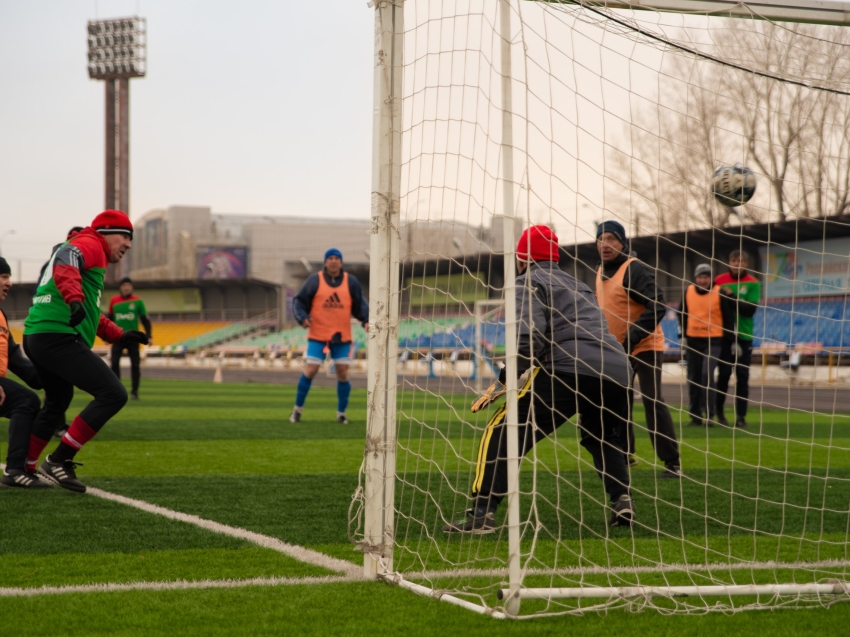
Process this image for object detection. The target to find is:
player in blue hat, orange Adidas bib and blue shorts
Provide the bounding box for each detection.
[289,248,369,425]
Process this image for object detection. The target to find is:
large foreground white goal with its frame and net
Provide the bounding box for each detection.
[350,0,850,617]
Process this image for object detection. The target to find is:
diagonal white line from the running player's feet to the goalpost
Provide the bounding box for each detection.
[86,487,363,579]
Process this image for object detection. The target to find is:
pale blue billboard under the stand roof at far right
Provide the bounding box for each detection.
[759,237,850,298]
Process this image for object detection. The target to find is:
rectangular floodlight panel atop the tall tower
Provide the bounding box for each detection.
[88,16,147,80]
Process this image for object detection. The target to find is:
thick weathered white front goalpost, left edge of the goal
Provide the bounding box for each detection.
[363,0,404,579]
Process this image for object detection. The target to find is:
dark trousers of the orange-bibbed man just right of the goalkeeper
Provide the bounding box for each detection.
[620,351,679,464]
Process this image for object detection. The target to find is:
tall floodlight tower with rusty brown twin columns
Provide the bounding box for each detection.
[88,16,147,280]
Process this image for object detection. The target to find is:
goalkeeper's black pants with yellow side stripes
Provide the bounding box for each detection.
[472,368,629,509]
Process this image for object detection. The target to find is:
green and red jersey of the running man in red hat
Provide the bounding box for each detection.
[24,228,124,347]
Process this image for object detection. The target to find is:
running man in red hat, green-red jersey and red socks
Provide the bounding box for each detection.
[24,210,148,493]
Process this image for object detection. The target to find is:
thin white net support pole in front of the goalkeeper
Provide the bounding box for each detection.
[499,0,522,615]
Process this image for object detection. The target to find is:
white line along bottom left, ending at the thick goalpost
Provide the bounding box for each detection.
[0,575,359,597]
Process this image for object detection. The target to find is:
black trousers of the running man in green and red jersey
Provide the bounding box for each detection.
[24,334,127,440]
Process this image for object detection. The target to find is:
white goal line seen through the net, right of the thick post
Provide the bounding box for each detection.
[412,560,850,580]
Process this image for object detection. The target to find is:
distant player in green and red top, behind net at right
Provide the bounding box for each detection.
[714,250,761,428]
